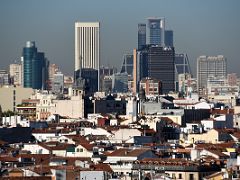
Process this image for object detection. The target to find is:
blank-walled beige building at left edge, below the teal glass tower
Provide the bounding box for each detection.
[0,86,34,111]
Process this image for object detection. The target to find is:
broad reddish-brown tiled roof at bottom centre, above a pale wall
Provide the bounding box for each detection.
[108,148,150,157]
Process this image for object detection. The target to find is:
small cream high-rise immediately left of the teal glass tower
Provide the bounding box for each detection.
[9,63,22,86]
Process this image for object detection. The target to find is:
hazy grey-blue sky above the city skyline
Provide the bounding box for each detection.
[0,0,240,75]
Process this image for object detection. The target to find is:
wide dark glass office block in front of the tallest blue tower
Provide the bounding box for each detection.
[147,46,175,93]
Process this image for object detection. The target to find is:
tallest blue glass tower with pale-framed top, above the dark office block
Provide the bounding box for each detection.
[147,17,165,46]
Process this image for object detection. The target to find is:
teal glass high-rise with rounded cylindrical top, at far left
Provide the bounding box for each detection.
[22,41,49,89]
